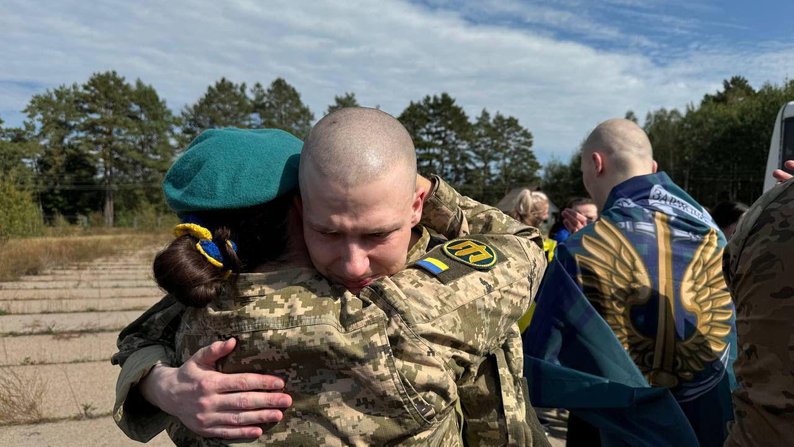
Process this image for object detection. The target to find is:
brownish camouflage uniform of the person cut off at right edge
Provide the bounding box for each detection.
[723,180,794,447]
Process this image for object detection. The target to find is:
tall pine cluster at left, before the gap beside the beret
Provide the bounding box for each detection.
[25,71,174,226]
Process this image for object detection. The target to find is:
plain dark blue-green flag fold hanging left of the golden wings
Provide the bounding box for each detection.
[523,260,698,447]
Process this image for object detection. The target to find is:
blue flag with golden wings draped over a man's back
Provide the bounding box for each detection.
[525,173,736,446]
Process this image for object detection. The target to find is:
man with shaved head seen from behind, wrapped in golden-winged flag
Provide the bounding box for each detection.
[538,119,736,446]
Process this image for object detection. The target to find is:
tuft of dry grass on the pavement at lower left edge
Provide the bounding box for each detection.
[0,368,47,425]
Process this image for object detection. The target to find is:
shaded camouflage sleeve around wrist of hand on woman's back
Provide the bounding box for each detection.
[111,296,184,442]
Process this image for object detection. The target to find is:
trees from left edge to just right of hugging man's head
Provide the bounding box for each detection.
[0,71,540,236]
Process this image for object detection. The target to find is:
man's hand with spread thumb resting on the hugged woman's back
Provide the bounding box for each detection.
[138,339,292,439]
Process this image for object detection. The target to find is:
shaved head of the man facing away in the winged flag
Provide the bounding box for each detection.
[582,119,656,210]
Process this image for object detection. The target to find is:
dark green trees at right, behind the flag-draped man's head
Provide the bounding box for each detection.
[541,76,794,207]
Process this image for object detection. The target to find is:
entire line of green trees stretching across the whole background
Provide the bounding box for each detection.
[0,71,794,236]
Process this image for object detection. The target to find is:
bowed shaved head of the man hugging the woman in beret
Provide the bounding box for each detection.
[299,108,426,293]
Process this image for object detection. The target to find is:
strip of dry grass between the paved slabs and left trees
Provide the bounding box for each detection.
[0,232,171,281]
